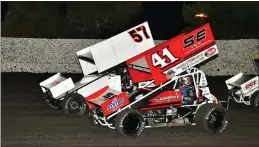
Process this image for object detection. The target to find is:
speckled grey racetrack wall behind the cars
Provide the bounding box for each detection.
[1,37,259,76]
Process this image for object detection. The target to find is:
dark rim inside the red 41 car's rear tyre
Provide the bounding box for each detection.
[207,109,228,132]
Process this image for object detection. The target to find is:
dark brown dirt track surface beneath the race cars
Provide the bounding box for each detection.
[1,73,259,147]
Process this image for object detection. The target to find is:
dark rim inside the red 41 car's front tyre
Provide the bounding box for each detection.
[123,115,140,135]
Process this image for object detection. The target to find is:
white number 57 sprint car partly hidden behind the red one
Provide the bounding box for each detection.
[39,22,155,117]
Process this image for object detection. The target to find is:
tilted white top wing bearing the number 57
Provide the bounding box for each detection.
[77,22,155,75]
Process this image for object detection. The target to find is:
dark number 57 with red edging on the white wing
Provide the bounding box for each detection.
[128,25,150,43]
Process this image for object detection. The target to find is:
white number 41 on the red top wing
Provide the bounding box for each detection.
[151,47,179,68]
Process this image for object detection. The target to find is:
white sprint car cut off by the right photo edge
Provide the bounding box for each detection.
[225,53,259,111]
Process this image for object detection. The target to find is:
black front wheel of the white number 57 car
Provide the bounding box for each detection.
[62,93,87,117]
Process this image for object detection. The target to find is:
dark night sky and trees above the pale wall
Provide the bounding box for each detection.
[1,1,259,40]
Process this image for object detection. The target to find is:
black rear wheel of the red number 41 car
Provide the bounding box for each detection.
[195,104,228,134]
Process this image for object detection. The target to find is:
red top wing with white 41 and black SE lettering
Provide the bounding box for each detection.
[126,24,218,85]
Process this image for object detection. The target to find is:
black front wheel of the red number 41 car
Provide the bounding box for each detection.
[115,109,145,138]
